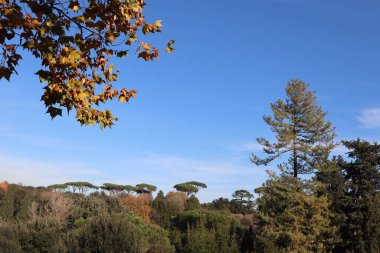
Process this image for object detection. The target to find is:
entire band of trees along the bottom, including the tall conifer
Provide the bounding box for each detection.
[0,80,380,253]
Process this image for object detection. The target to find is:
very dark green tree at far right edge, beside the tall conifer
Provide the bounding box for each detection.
[317,139,380,253]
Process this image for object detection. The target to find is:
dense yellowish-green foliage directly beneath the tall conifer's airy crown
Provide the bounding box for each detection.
[255,173,335,253]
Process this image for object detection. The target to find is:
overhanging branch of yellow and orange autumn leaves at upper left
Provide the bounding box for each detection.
[0,0,174,128]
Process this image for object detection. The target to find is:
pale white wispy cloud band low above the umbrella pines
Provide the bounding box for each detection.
[0,151,266,201]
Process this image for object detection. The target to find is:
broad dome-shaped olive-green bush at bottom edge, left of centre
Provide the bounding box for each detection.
[71,214,174,253]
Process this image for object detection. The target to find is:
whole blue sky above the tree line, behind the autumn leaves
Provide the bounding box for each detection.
[0,0,380,201]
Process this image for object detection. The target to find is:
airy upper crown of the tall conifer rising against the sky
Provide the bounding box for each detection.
[251,80,335,178]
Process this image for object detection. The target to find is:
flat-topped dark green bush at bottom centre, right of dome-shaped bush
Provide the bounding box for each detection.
[172,209,240,253]
